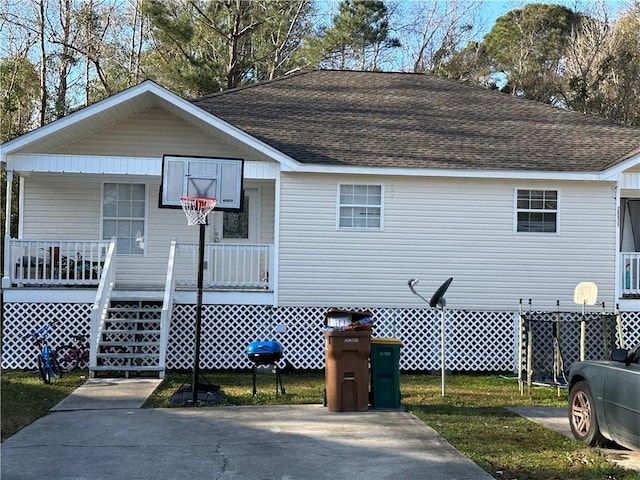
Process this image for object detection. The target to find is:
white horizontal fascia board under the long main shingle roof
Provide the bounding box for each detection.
[297,165,609,181]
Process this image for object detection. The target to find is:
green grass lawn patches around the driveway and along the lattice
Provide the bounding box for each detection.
[1,371,640,480]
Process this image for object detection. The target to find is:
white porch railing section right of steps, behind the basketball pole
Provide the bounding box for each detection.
[176,243,272,290]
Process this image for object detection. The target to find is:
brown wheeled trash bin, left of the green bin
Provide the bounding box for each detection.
[324,330,371,412]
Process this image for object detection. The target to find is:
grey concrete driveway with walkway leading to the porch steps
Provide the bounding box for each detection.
[1,379,492,480]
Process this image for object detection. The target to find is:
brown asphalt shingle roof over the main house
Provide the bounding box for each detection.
[193,70,640,172]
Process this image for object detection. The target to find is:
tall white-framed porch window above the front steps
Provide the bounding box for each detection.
[102,183,147,255]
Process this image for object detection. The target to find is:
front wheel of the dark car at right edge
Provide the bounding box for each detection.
[569,381,605,446]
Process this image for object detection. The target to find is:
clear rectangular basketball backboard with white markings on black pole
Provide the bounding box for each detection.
[159,155,244,210]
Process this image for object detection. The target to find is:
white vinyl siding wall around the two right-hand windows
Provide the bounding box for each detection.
[278,173,616,310]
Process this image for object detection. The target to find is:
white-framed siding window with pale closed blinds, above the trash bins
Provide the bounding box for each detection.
[338,184,382,230]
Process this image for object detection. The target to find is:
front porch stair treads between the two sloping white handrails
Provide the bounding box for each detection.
[91,298,164,378]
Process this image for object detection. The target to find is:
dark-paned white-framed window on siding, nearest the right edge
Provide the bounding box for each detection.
[516,189,558,233]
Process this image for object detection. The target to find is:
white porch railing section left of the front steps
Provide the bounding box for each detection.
[9,239,109,286]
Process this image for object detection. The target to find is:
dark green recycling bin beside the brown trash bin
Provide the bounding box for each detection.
[370,338,402,408]
